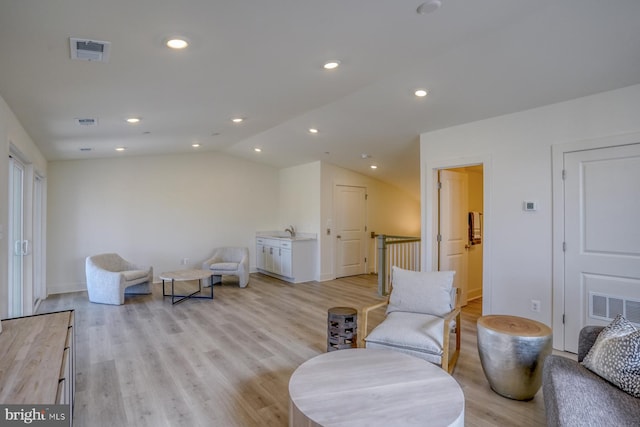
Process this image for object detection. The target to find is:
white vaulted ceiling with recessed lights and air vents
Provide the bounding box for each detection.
[0,0,640,197]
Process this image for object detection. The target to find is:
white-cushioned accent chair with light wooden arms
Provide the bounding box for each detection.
[358,266,460,373]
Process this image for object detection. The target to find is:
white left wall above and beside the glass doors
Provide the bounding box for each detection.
[0,97,47,317]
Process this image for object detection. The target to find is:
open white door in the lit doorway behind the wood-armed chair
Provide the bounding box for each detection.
[438,170,469,305]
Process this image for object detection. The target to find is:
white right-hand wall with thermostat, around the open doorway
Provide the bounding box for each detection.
[420,85,640,325]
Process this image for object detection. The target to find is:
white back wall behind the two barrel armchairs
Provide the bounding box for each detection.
[47,152,279,293]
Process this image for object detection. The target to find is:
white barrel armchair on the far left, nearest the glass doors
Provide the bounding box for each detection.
[85,253,153,305]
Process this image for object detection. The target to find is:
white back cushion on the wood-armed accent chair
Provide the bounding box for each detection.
[387,266,455,316]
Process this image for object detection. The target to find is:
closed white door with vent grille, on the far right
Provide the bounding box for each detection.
[564,144,640,352]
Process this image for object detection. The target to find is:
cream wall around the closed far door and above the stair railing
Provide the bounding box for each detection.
[319,162,420,280]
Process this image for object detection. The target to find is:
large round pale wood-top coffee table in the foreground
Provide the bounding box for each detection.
[289,348,464,427]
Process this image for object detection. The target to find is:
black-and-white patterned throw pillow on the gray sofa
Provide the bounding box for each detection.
[582,314,640,397]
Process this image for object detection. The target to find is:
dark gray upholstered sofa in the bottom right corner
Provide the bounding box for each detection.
[542,326,640,427]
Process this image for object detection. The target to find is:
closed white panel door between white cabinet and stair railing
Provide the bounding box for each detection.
[334,185,367,277]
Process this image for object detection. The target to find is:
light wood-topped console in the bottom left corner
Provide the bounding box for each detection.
[0,310,75,425]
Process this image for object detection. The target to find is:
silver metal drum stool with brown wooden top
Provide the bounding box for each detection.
[478,315,552,400]
